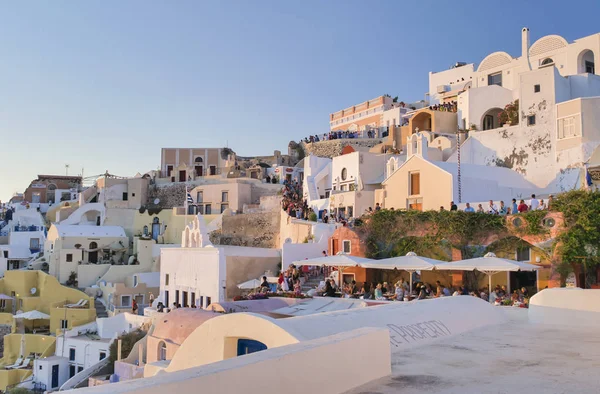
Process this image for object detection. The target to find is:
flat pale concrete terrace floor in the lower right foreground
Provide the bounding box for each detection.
[351,310,600,394]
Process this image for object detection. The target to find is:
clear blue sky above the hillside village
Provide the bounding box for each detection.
[0,0,600,201]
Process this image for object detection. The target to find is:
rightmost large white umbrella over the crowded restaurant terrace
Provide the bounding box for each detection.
[435,253,540,293]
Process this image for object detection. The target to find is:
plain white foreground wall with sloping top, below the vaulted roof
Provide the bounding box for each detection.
[73,328,391,394]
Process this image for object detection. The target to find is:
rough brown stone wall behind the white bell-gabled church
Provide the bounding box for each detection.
[210,211,280,248]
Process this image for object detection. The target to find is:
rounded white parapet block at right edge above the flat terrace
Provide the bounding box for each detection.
[529,288,600,328]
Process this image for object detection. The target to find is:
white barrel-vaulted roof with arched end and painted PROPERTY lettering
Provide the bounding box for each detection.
[162,296,508,377]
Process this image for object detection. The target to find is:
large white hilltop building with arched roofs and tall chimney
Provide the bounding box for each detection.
[450,28,600,193]
